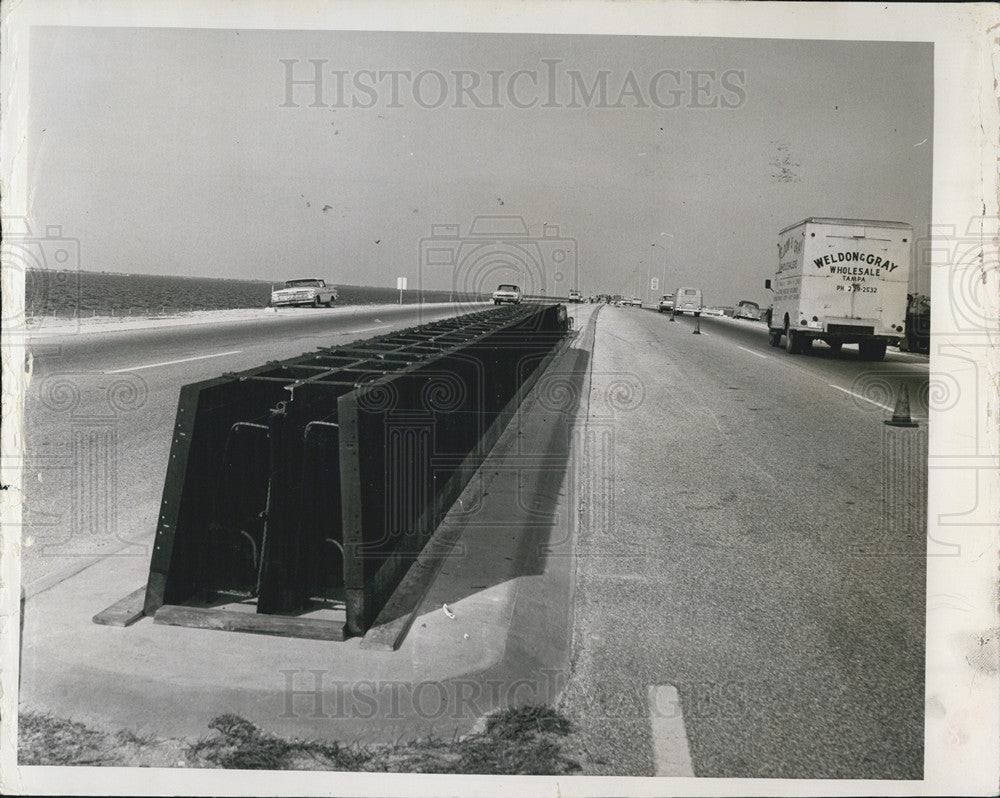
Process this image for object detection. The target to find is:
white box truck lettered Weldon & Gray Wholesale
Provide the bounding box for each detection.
[764,218,913,360]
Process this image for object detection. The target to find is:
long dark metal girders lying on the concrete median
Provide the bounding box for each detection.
[128,304,567,639]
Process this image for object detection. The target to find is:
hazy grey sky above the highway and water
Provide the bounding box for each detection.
[28,28,933,305]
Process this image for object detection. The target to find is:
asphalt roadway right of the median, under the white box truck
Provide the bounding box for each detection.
[564,307,928,779]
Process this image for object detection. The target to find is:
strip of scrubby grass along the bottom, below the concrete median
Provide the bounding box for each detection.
[18,706,580,775]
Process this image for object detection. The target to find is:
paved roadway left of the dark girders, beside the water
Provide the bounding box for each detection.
[22,305,491,592]
